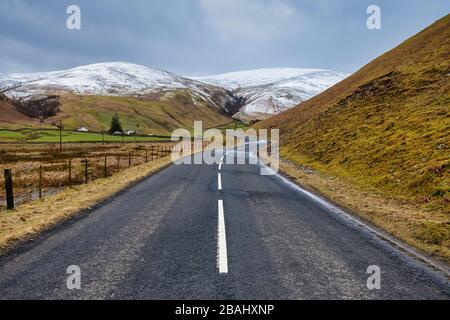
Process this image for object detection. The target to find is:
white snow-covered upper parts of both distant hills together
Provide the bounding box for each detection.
[0,62,348,120]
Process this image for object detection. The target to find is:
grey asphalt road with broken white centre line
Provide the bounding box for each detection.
[0,148,450,299]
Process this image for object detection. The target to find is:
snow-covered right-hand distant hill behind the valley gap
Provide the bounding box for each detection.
[193,68,349,120]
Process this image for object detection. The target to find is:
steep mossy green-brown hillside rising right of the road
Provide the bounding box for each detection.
[257,15,450,215]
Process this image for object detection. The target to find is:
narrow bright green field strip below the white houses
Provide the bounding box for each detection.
[0,129,170,143]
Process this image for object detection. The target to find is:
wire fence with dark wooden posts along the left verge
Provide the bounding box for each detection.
[0,144,182,209]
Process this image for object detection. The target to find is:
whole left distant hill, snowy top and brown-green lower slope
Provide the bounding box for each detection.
[0,62,234,135]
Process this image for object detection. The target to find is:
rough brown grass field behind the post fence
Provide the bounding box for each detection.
[0,143,176,210]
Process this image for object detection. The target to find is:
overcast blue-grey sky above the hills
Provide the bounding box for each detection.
[0,0,450,75]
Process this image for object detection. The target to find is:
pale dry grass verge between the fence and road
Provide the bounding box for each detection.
[0,157,171,251]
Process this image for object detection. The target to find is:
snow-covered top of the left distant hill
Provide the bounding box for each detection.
[0,62,231,111]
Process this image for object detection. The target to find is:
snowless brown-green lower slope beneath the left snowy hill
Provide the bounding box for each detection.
[0,90,233,135]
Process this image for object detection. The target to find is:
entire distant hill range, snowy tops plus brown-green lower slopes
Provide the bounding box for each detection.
[0,62,347,130]
